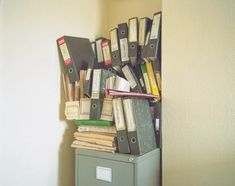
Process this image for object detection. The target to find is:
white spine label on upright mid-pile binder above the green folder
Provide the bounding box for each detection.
[91,69,101,99]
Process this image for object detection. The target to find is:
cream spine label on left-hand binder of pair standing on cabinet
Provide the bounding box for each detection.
[113,98,125,131]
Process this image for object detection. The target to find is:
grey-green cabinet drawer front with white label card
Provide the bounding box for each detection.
[76,155,135,186]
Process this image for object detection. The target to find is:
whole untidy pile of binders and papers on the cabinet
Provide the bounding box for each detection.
[57,12,161,155]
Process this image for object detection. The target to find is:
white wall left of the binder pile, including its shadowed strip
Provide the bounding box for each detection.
[0,0,103,186]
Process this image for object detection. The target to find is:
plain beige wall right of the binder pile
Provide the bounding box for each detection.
[162,0,235,186]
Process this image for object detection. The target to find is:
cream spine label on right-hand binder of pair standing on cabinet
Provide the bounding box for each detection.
[123,99,136,132]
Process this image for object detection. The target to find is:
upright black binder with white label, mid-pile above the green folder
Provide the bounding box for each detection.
[90,69,111,120]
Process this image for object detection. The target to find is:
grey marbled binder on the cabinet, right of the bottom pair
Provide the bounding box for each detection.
[123,98,156,155]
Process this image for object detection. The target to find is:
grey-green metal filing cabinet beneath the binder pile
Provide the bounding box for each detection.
[75,149,160,186]
